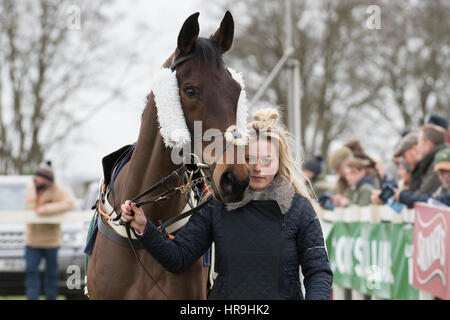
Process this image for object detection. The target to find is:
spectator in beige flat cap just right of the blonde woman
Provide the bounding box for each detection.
[328,146,353,206]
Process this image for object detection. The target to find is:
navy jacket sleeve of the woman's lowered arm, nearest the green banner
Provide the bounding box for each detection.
[297,198,333,300]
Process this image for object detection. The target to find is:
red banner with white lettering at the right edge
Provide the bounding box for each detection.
[413,203,450,300]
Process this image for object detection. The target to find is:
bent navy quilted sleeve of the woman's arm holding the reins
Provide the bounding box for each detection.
[136,207,212,273]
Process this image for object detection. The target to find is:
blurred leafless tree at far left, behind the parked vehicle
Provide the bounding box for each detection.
[0,0,132,174]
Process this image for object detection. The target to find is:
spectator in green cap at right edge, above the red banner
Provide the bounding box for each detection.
[394,148,450,208]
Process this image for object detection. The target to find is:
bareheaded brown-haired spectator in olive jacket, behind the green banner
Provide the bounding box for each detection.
[341,158,375,206]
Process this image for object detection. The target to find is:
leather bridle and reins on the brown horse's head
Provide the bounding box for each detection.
[100,53,246,299]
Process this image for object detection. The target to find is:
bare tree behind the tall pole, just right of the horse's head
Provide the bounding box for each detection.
[214,0,379,156]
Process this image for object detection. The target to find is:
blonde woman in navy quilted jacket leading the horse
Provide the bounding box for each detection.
[121,109,333,300]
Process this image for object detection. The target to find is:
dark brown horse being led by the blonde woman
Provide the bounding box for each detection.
[87,11,249,300]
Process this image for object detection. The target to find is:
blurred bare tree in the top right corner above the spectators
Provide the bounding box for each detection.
[362,0,450,132]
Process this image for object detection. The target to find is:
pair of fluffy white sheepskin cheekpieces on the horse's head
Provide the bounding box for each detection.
[152,68,248,148]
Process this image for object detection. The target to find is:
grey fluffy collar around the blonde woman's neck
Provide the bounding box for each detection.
[225,175,295,214]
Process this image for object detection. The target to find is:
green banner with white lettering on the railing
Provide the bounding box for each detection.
[326,222,419,299]
